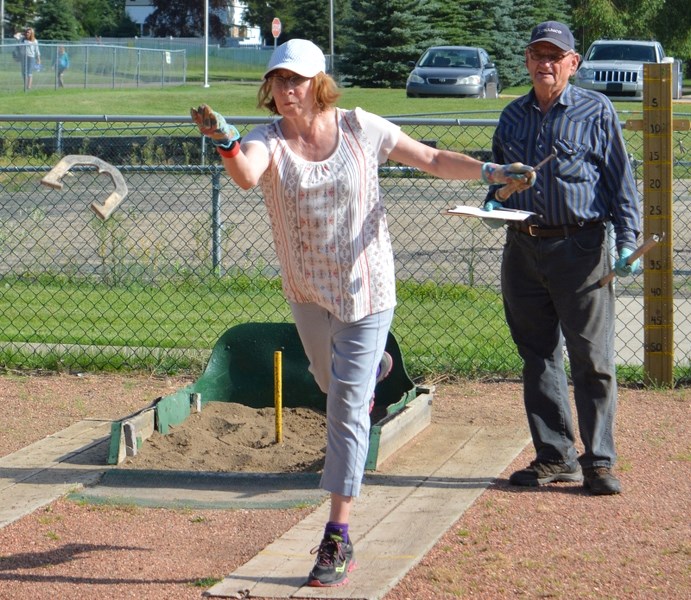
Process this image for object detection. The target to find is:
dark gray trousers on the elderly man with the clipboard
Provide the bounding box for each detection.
[501,224,617,467]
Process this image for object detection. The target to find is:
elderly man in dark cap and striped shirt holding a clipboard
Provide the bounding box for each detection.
[484,21,641,495]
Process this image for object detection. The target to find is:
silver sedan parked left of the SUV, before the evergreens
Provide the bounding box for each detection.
[405,46,501,98]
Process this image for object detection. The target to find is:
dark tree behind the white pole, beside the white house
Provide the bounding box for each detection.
[146,0,227,38]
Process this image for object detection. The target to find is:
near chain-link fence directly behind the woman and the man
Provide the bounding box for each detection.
[0,115,691,379]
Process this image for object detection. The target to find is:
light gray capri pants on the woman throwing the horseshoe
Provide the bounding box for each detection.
[290,302,394,496]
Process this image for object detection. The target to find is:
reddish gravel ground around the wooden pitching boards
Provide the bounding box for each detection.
[0,374,691,600]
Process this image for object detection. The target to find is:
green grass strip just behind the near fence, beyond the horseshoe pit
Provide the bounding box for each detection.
[0,276,520,377]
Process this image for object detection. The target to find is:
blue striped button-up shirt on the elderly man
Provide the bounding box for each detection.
[488,84,641,248]
